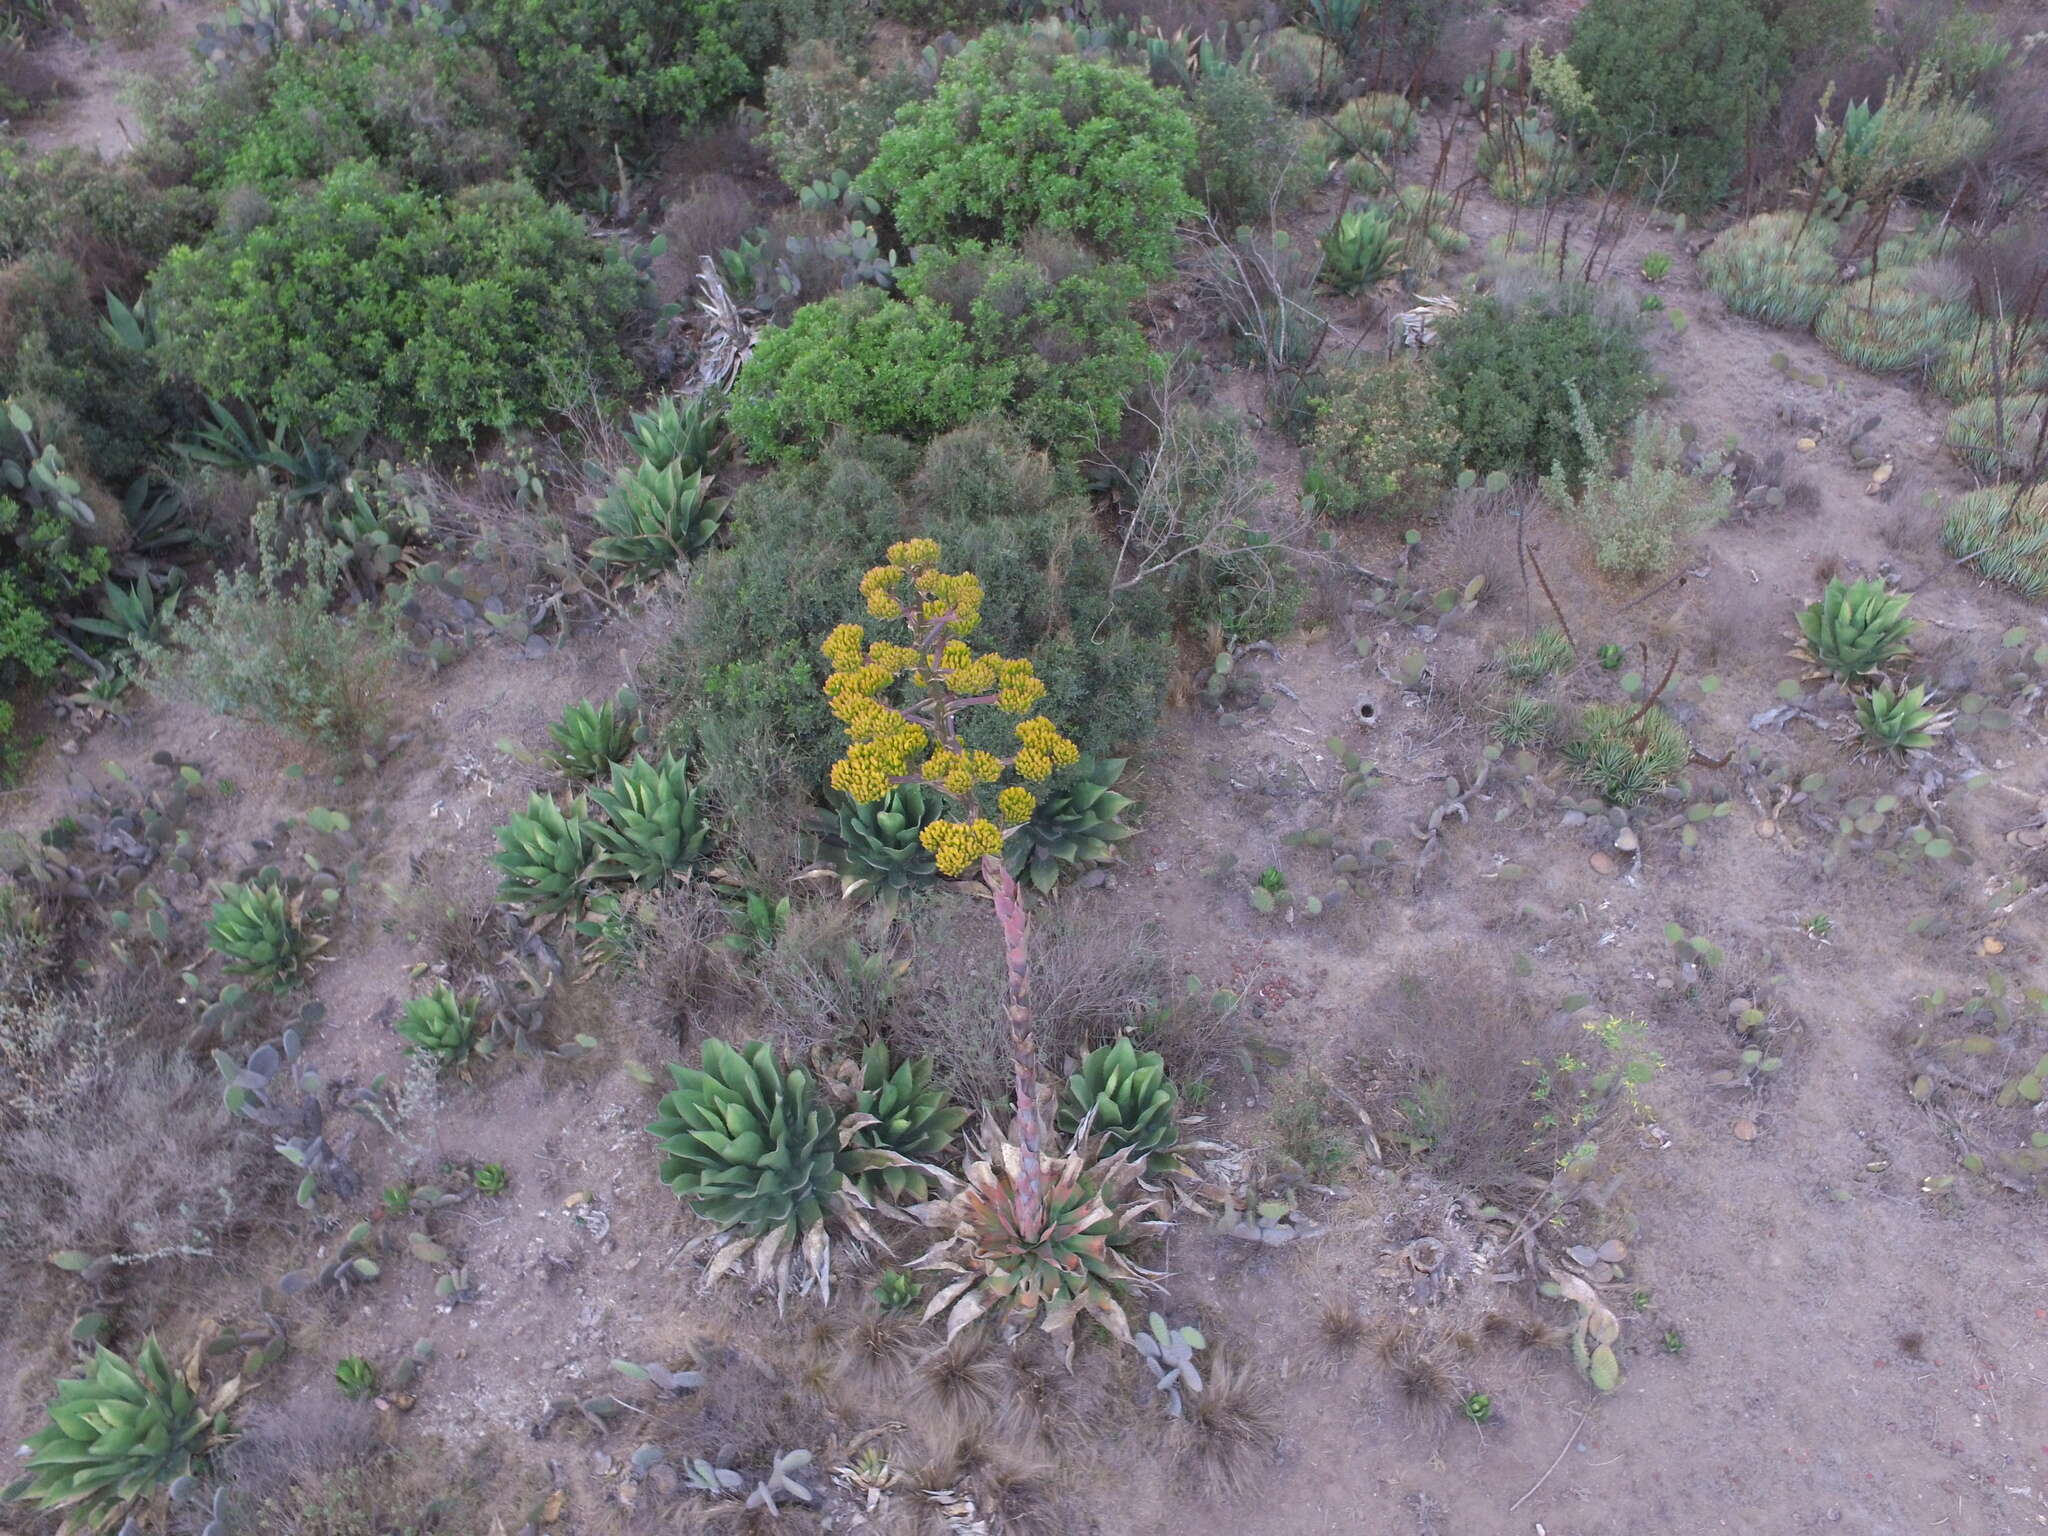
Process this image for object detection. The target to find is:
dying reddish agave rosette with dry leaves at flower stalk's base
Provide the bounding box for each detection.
[909,1122,1165,1358]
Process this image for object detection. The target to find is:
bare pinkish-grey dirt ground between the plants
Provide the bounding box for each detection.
[4,72,2048,1536]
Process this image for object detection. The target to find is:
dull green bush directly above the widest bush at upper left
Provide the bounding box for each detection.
[195,27,520,195]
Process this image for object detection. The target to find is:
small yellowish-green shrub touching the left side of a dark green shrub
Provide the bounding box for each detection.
[1303,358,1458,518]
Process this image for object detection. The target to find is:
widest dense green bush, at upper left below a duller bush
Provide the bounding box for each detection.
[154,162,641,446]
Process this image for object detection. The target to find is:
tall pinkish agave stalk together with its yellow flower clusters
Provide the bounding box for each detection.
[821,539,1081,1237]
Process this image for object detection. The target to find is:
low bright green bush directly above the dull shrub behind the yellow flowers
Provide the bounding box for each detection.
[731,287,1016,461]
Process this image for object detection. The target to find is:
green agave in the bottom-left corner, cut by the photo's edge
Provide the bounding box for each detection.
[0,1333,233,1536]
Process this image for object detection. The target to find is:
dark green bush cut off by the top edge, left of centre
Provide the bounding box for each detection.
[463,0,774,180]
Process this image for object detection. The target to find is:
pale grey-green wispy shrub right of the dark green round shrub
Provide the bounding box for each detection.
[1542,391,1735,580]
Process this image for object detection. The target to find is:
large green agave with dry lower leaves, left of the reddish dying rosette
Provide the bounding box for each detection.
[647,1038,899,1300]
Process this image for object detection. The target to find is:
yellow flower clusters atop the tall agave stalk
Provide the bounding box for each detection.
[819,539,1081,877]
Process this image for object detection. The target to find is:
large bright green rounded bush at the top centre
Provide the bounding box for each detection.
[862,29,1196,276]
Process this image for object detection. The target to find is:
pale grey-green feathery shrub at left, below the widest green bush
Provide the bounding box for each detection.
[137,510,403,758]
